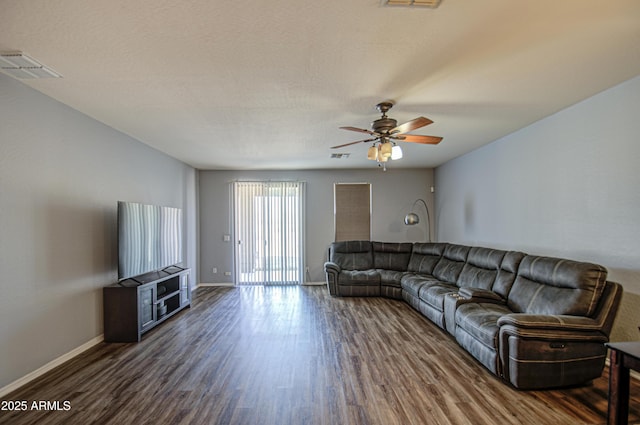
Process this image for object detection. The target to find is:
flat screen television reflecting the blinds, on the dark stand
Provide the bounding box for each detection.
[118,201,182,281]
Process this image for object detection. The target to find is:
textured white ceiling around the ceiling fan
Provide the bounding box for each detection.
[0,0,640,169]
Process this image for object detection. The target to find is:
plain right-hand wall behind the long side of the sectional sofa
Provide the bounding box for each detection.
[435,76,640,340]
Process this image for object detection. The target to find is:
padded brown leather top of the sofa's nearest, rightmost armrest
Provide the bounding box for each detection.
[498,313,602,333]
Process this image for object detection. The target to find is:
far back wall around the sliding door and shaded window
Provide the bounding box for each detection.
[199,167,433,283]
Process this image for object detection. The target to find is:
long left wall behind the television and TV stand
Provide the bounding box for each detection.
[0,74,197,389]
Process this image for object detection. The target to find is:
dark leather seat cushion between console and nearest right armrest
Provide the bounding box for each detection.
[455,303,512,350]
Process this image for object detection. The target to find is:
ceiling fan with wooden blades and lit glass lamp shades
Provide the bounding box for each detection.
[331,101,442,162]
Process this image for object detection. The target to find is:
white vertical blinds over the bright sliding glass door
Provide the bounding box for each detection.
[233,181,305,285]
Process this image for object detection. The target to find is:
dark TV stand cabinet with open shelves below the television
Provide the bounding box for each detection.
[103,267,191,342]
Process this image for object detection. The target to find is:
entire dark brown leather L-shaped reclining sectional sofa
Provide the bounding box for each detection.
[324,241,622,389]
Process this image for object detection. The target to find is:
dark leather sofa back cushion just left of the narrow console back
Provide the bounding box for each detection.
[458,247,506,290]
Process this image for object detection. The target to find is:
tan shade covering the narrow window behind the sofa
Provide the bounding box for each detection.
[333,183,371,242]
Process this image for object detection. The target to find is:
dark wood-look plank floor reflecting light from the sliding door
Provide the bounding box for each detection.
[0,286,640,425]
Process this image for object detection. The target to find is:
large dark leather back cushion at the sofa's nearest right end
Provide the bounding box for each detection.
[507,255,607,316]
